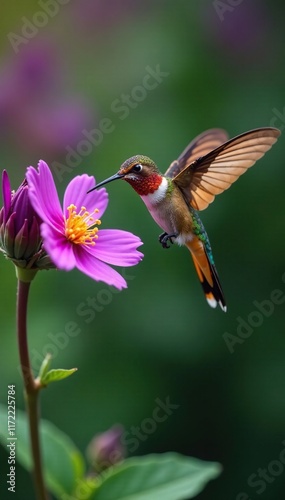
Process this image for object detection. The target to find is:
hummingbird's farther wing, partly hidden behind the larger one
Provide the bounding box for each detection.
[164,128,229,179]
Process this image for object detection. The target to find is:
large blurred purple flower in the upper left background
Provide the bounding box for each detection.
[0,40,94,155]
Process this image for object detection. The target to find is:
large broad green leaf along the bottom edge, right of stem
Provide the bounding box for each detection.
[88,453,222,500]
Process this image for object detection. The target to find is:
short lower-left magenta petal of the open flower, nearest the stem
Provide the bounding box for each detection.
[41,222,76,271]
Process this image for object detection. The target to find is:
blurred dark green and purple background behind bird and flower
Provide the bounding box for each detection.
[0,0,285,500]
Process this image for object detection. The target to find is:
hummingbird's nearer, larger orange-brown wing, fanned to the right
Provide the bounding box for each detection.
[173,127,281,210]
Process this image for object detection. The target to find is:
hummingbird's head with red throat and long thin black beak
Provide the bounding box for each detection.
[88,155,162,196]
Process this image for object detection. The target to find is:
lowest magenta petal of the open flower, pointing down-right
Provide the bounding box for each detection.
[74,245,127,290]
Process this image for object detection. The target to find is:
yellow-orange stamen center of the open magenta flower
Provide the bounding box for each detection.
[65,205,101,246]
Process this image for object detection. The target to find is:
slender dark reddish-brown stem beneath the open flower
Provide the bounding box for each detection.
[17,279,48,500]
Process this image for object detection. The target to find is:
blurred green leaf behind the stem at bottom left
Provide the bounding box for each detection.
[0,405,85,498]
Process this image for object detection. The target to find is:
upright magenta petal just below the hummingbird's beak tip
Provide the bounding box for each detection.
[63,174,108,218]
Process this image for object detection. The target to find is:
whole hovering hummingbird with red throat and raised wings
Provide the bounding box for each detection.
[88,127,280,311]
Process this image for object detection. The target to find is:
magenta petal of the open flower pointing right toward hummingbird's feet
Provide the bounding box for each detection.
[87,229,143,267]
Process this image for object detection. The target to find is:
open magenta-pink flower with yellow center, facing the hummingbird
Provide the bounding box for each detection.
[26,160,143,290]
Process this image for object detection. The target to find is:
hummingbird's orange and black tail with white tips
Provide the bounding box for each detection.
[187,238,227,312]
